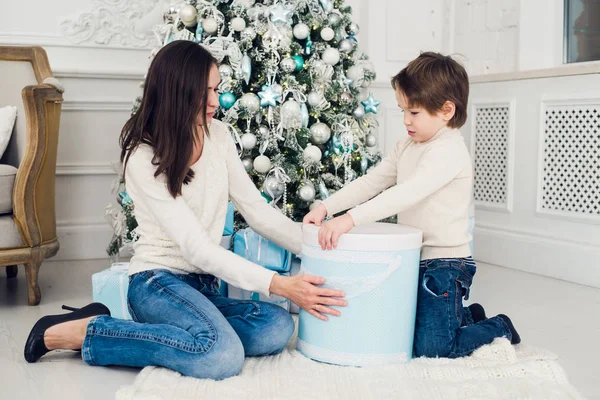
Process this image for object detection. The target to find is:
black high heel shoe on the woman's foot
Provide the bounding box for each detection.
[24,303,110,363]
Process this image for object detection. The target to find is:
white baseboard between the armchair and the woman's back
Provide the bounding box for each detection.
[52,222,113,261]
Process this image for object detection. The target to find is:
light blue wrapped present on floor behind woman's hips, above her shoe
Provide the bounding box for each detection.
[92,262,131,319]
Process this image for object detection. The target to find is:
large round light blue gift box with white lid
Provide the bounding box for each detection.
[298,223,423,366]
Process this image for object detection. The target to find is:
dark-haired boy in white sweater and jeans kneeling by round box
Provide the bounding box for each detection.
[304,52,521,358]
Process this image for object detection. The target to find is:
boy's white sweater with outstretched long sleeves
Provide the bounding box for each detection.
[323,127,473,260]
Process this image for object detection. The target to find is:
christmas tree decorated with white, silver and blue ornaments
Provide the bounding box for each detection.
[107,0,381,254]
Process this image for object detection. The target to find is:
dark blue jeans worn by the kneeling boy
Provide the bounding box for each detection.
[414,257,511,358]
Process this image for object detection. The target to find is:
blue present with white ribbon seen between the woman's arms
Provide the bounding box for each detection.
[233,228,292,272]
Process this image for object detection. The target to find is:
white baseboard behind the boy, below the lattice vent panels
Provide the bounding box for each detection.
[474,224,600,291]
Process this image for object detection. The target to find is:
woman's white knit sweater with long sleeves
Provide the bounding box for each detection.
[125,120,302,295]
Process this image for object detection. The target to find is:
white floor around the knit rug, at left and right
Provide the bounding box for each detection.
[0,260,600,400]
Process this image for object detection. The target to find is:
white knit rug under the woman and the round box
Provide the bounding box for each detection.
[116,330,583,400]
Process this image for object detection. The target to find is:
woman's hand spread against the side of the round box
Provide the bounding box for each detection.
[269,274,348,321]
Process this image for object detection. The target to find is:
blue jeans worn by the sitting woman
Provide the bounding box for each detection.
[81,270,294,379]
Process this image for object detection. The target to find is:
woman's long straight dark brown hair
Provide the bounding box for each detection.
[120,40,217,198]
